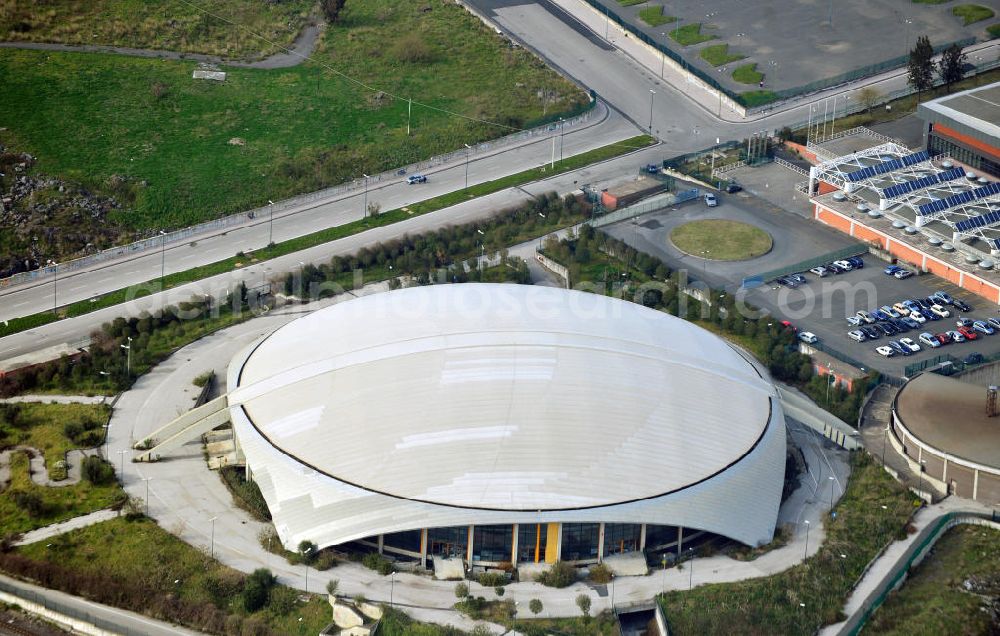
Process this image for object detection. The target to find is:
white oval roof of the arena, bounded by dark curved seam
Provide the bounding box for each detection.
[230,284,773,511]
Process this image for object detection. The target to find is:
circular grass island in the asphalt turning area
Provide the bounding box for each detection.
[670,219,773,261]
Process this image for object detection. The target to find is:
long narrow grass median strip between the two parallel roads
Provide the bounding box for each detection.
[0,135,655,342]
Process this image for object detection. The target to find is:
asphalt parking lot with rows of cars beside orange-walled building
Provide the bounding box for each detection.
[747,255,1000,376]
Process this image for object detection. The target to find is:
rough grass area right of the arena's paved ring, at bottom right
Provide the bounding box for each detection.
[660,452,915,636]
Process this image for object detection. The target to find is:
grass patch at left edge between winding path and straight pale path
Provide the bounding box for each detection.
[0,453,122,537]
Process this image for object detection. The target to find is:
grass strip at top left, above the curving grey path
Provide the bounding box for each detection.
[0,0,314,59]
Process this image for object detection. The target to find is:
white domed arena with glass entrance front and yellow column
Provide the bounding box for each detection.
[228,283,785,565]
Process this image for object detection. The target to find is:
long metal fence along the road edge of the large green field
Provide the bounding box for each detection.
[0,98,597,289]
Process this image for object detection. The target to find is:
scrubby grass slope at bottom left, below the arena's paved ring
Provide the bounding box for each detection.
[7,517,330,634]
